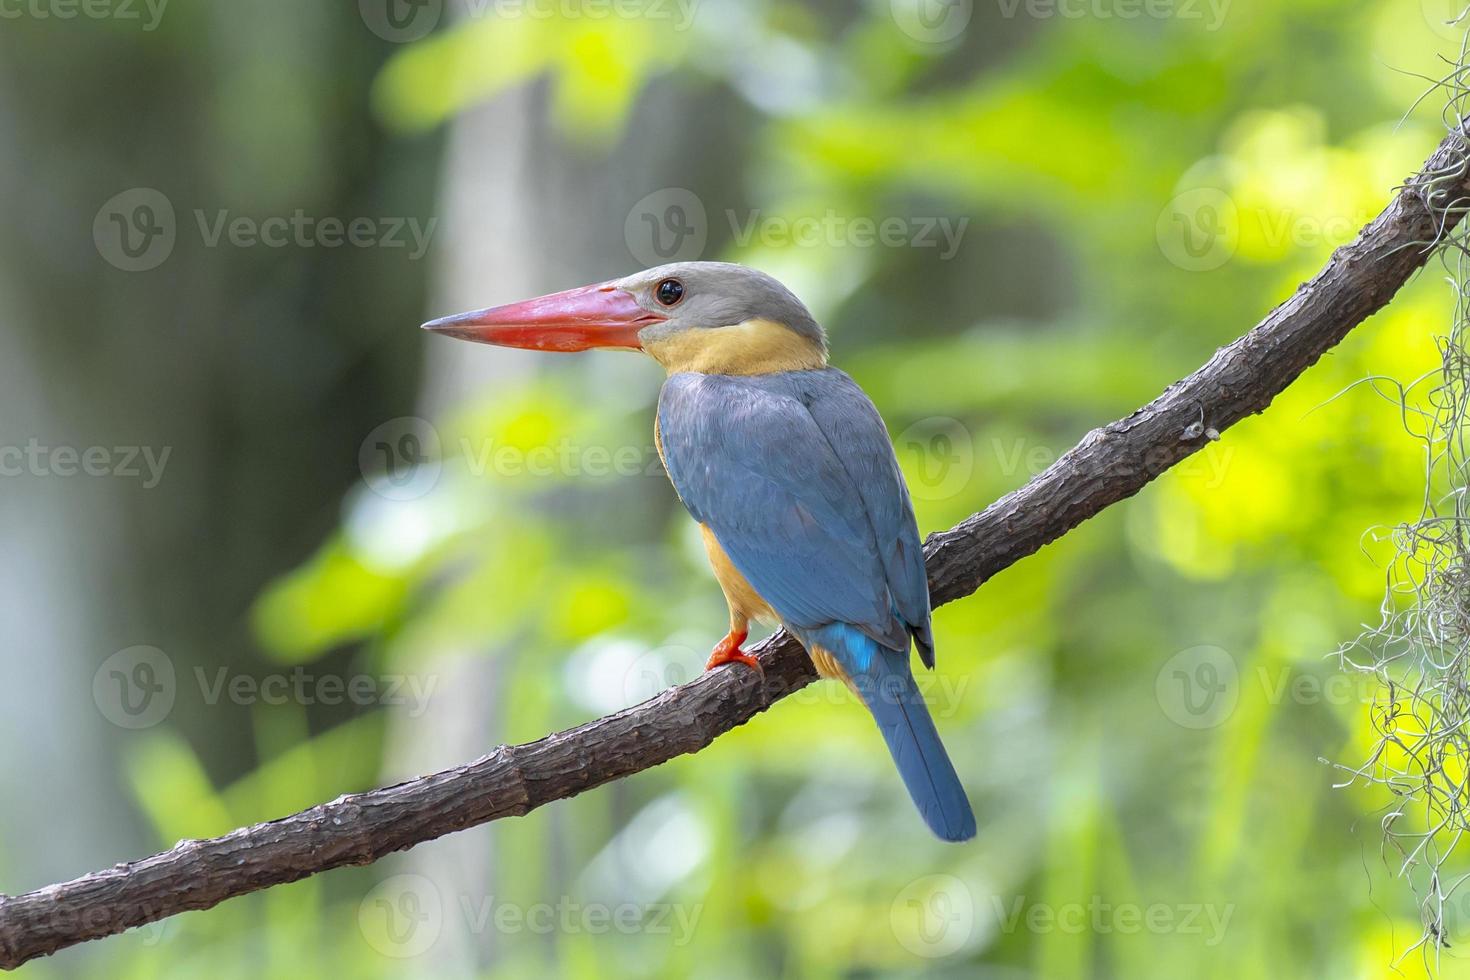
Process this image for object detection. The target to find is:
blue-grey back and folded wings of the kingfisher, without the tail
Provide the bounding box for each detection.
[659,369,933,666]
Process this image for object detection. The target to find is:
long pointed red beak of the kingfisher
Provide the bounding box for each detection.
[423,282,669,351]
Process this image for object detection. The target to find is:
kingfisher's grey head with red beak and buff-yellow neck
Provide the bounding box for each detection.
[423,262,826,375]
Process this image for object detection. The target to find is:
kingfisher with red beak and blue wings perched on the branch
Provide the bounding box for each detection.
[423,262,976,842]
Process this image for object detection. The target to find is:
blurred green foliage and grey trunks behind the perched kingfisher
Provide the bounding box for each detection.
[0,0,1470,980]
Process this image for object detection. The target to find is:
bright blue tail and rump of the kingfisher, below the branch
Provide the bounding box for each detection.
[807,623,975,840]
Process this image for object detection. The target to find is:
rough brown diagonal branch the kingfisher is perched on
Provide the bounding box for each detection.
[0,132,1470,968]
